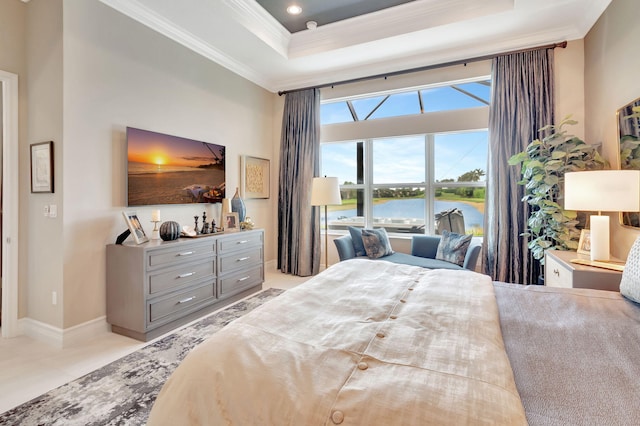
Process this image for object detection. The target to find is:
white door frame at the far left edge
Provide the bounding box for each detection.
[0,70,20,338]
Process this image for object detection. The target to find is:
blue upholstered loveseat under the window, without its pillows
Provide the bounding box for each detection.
[333,234,480,271]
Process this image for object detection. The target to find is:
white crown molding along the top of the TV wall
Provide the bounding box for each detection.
[100,0,271,90]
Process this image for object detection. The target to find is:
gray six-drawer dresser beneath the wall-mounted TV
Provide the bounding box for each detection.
[107,229,264,341]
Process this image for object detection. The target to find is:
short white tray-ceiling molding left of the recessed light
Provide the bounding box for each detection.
[222,0,291,58]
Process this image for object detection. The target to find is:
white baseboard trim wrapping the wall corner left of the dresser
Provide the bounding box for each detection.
[18,316,110,349]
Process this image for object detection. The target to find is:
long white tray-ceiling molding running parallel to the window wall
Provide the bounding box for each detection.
[289,0,514,58]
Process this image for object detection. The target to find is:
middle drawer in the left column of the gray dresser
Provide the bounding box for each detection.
[148,257,216,294]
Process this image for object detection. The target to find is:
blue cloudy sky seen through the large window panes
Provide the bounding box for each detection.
[321,83,490,184]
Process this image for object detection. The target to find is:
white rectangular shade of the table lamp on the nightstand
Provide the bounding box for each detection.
[564,170,640,212]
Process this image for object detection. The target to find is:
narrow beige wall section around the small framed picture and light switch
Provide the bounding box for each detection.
[25,0,64,328]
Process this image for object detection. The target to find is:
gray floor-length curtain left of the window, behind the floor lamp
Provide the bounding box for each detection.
[278,89,321,277]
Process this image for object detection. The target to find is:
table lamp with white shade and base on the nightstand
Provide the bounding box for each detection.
[564,170,640,261]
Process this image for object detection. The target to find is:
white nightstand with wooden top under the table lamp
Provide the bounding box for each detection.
[544,250,622,291]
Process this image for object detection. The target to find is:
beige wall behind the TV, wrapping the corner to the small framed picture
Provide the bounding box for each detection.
[12,0,277,329]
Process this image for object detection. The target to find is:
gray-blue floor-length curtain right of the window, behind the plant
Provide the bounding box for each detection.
[483,48,554,284]
